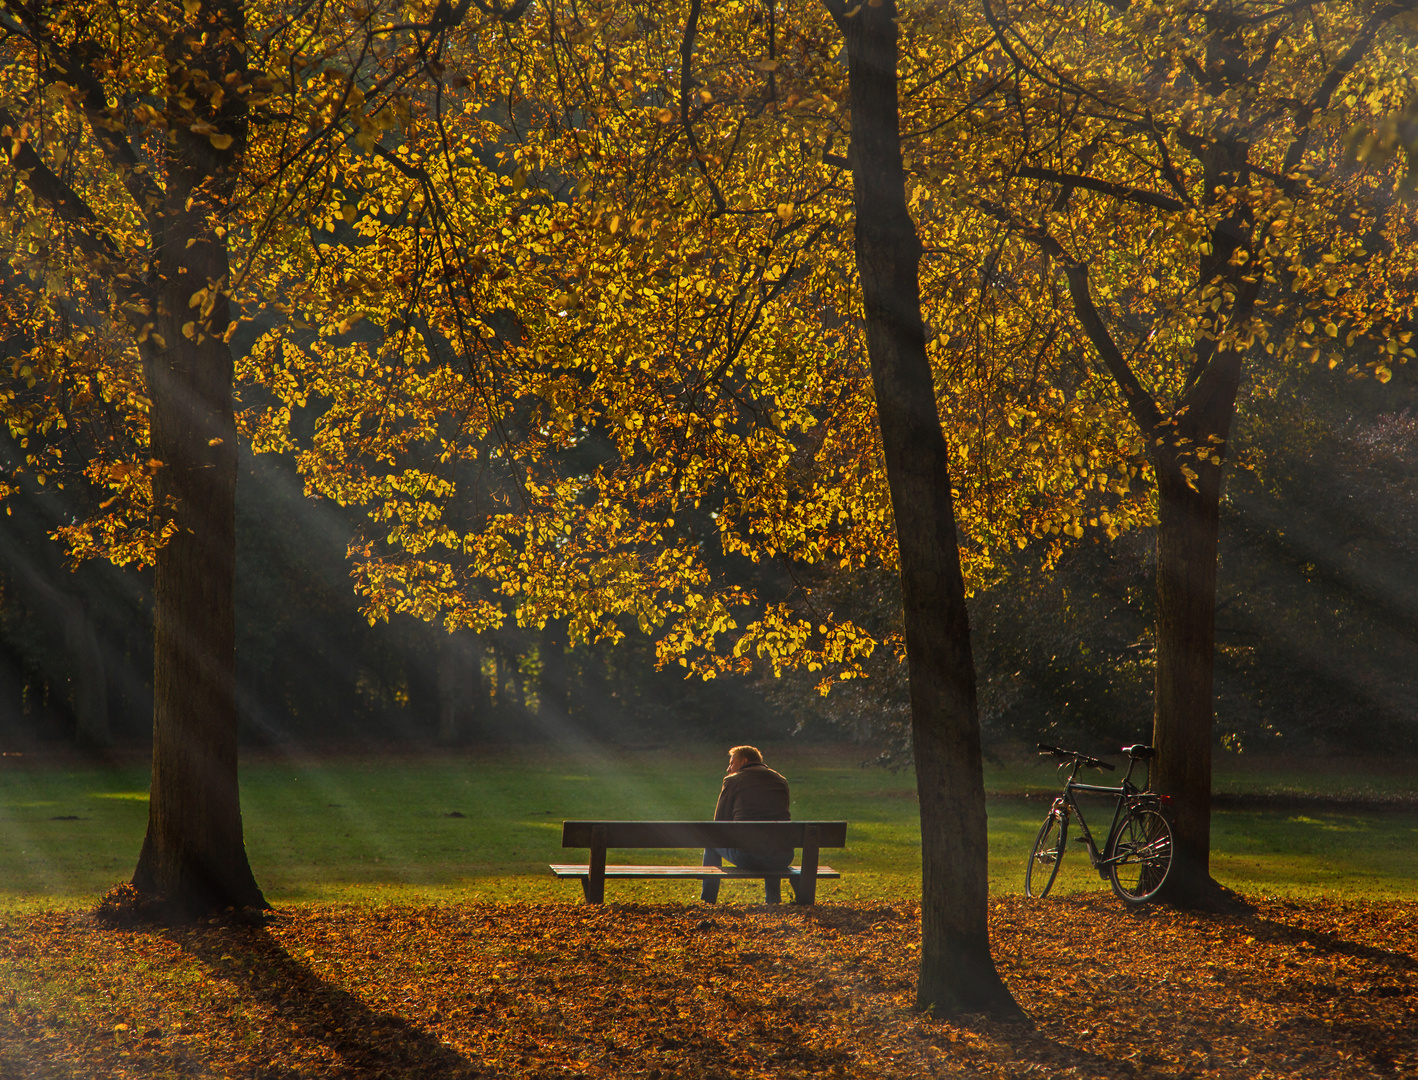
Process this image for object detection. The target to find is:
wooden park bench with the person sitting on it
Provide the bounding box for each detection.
[552,821,847,904]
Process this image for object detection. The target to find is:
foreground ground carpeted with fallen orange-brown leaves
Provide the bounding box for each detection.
[0,896,1418,1080]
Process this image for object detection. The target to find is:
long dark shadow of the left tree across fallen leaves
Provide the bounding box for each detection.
[167,927,488,1080]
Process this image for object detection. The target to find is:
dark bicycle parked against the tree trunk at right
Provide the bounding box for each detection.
[1024,743,1171,904]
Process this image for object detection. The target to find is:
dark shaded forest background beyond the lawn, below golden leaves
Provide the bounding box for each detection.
[0,357,1418,754]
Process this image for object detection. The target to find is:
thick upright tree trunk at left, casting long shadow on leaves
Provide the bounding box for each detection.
[133,0,267,914]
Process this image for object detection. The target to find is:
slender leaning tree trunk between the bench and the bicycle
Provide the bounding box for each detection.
[834,0,1018,1015]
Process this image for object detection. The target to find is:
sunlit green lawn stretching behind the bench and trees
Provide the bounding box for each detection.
[0,747,1418,907]
